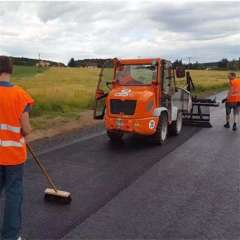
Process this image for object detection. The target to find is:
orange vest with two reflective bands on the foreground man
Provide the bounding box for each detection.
[0,86,34,165]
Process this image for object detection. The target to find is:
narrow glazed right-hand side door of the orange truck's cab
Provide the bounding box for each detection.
[161,62,175,121]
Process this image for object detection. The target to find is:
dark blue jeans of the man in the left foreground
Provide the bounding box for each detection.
[0,164,23,240]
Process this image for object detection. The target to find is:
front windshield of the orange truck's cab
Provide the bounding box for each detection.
[116,65,157,86]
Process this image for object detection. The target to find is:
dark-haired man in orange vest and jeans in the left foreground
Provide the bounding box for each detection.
[0,56,34,240]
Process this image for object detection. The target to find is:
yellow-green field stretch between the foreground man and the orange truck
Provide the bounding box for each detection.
[13,67,99,129]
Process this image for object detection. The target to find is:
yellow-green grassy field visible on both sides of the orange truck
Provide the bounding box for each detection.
[13,66,236,129]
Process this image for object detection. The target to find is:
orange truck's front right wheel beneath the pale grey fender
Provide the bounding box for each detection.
[153,112,168,144]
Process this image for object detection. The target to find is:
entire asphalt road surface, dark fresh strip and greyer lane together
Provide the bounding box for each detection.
[0,93,240,240]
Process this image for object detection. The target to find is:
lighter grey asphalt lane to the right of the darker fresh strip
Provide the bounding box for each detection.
[64,98,240,240]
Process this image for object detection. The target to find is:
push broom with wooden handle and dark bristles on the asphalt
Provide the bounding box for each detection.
[27,144,72,204]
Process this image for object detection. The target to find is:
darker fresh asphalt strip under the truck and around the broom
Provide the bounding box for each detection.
[0,128,199,239]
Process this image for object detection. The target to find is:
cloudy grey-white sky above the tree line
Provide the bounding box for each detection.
[0,0,240,63]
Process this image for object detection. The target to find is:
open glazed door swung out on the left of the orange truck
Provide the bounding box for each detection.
[93,60,114,119]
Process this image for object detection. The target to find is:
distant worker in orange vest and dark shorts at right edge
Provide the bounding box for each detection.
[222,72,240,131]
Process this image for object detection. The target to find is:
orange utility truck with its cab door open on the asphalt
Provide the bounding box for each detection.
[94,58,192,144]
